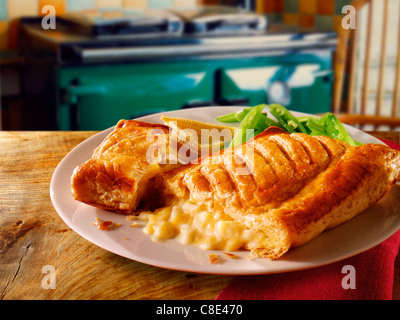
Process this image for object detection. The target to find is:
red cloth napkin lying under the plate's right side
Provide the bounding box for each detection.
[217,139,400,300]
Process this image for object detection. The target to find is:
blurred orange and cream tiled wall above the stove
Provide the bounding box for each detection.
[0,0,351,50]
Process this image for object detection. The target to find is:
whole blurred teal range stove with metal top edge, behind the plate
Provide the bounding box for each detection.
[19,8,336,130]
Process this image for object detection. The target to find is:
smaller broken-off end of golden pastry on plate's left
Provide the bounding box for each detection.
[71,120,178,214]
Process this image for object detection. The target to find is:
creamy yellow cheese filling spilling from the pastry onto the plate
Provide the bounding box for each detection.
[139,200,266,251]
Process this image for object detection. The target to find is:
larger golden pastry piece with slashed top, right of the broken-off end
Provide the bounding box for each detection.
[156,133,400,259]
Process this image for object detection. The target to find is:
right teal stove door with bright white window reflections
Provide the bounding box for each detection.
[220,55,333,113]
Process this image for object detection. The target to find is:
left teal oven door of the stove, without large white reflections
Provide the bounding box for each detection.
[59,63,214,130]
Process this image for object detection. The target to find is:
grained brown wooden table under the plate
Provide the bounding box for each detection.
[0,131,400,300]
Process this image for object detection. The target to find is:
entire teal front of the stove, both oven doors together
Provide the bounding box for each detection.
[58,50,333,130]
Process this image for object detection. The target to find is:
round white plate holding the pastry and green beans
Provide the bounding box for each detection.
[50,107,400,275]
